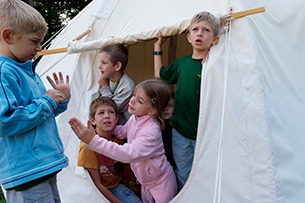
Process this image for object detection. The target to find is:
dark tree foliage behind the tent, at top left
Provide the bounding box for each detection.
[23,0,92,45]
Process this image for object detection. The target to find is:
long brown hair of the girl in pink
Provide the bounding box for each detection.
[135,78,171,130]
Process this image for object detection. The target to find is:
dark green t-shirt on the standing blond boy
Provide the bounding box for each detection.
[160,55,202,140]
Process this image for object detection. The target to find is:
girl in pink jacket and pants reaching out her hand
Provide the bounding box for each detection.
[69,79,177,203]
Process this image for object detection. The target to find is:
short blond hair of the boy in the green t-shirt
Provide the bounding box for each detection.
[189,11,220,37]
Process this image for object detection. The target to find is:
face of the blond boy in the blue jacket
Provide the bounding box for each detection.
[8,32,45,63]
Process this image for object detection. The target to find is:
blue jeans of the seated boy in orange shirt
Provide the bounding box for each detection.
[110,184,142,203]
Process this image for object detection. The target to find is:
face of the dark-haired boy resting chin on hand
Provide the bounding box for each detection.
[98,52,118,78]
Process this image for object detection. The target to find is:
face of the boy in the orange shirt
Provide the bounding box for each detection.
[90,105,118,135]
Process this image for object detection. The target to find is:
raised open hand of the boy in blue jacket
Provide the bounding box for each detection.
[47,72,70,100]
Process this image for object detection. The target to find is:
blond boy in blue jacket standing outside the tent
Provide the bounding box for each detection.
[0,0,70,203]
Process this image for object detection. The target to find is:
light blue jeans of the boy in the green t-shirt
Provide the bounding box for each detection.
[172,128,196,191]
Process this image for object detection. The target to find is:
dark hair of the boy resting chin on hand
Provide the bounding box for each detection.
[100,44,128,72]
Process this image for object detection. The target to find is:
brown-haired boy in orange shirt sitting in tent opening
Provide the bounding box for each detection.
[78,97,141,203]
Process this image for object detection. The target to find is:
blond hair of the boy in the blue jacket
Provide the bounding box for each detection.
[0,0,48,35]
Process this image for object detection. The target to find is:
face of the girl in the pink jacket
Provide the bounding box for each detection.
[128,87,157,116]
